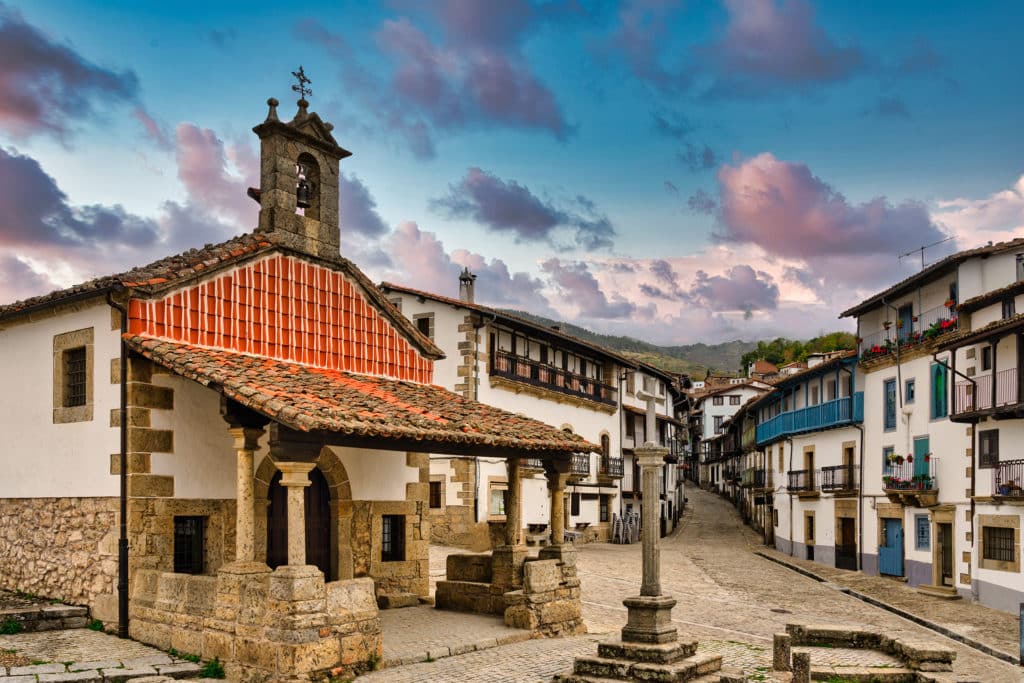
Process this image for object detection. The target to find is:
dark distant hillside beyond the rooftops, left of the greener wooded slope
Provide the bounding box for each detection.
[499,310,758,377]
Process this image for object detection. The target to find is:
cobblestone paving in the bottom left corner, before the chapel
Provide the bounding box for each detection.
[0,629,209,683]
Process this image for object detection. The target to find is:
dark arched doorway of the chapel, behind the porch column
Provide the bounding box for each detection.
[266,467,337,581]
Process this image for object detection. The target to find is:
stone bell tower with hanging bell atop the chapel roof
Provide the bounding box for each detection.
[253,83,352,258]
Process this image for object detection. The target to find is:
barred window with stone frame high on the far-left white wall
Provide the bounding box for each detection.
[53,328,93,424]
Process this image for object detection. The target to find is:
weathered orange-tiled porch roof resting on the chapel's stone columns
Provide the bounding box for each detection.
[125,335,601,453]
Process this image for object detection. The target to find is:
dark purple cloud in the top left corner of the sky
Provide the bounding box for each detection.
[0,3,138,140]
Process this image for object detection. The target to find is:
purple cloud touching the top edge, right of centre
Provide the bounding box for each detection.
[700,0,866,95]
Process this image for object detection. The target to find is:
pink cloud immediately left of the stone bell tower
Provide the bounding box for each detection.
[175,123,259,229]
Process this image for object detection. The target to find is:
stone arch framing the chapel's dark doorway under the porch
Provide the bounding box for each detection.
[253,446,353,581]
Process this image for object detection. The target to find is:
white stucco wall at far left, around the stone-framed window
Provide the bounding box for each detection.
[0,302,120,498]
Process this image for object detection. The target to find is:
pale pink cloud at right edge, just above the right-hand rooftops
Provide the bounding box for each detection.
[932,175,1024,248]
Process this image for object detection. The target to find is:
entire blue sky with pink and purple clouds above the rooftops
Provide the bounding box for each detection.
[0,0,1024,344]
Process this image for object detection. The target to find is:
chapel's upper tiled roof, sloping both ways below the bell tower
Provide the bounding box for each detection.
[0,232,444,358]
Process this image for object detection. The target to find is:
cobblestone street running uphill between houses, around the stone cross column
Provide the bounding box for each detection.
[368,488,1024,683]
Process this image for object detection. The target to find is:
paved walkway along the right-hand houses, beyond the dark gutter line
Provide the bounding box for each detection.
[761,548,1020,656]
